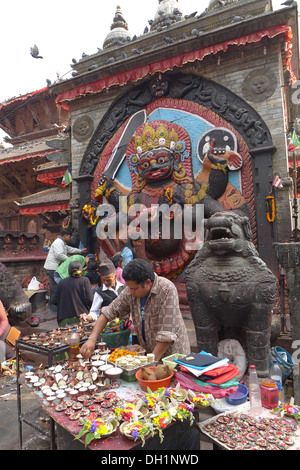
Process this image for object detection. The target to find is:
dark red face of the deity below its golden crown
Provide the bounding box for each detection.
[138,147,174,183]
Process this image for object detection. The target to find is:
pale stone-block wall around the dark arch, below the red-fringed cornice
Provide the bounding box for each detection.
[68,43,292,252]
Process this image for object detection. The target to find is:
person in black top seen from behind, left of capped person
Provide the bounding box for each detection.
[53,261,93,327]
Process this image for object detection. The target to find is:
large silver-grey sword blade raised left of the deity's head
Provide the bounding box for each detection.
[102,109,147,180]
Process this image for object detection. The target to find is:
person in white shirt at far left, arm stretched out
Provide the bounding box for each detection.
[44,229,87,312]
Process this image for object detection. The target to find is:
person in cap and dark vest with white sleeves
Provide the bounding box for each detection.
[81,261,125,321]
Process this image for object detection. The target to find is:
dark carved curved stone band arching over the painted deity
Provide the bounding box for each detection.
[79,74,273,175]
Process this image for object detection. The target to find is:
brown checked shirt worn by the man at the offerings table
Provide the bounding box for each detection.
[102,274,190,357]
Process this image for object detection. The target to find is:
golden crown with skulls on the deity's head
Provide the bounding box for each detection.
[134,122,178,155]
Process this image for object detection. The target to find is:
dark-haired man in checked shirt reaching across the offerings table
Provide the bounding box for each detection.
[80,258,190,361]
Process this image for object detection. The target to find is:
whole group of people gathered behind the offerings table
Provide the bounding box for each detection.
[44,229,190,361]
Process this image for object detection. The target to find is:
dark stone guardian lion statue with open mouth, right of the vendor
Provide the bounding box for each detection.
[185,212,277,377]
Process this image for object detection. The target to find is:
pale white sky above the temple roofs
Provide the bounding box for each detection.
[0,0,290,141]
